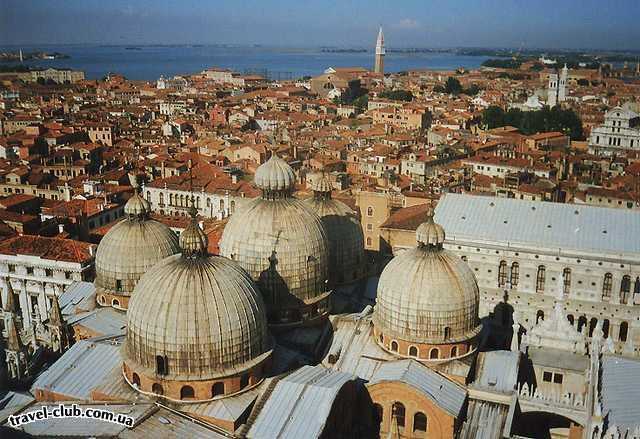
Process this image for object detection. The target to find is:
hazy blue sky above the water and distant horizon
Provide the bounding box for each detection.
[0,0,640,49]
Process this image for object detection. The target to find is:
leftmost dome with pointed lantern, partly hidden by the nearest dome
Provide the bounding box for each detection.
[95,189,180,309]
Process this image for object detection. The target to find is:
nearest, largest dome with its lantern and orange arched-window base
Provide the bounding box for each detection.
[124,211,271,401]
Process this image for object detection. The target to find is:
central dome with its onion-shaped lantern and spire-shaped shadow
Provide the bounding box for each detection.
[220,153,329,325]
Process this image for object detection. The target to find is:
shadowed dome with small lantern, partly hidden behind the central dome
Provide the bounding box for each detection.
[304,174,365,285]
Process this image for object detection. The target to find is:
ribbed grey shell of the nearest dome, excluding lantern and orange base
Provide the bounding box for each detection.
[125,254,271,381]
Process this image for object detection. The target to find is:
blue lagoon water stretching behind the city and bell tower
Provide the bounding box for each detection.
[0,45,496,80]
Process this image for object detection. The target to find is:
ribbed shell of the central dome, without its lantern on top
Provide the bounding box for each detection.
[220,197,329,324]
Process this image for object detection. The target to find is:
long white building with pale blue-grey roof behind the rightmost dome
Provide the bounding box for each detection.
[435,194,640,351]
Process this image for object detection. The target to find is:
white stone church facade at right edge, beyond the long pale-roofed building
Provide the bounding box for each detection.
[589,107,640,155]
